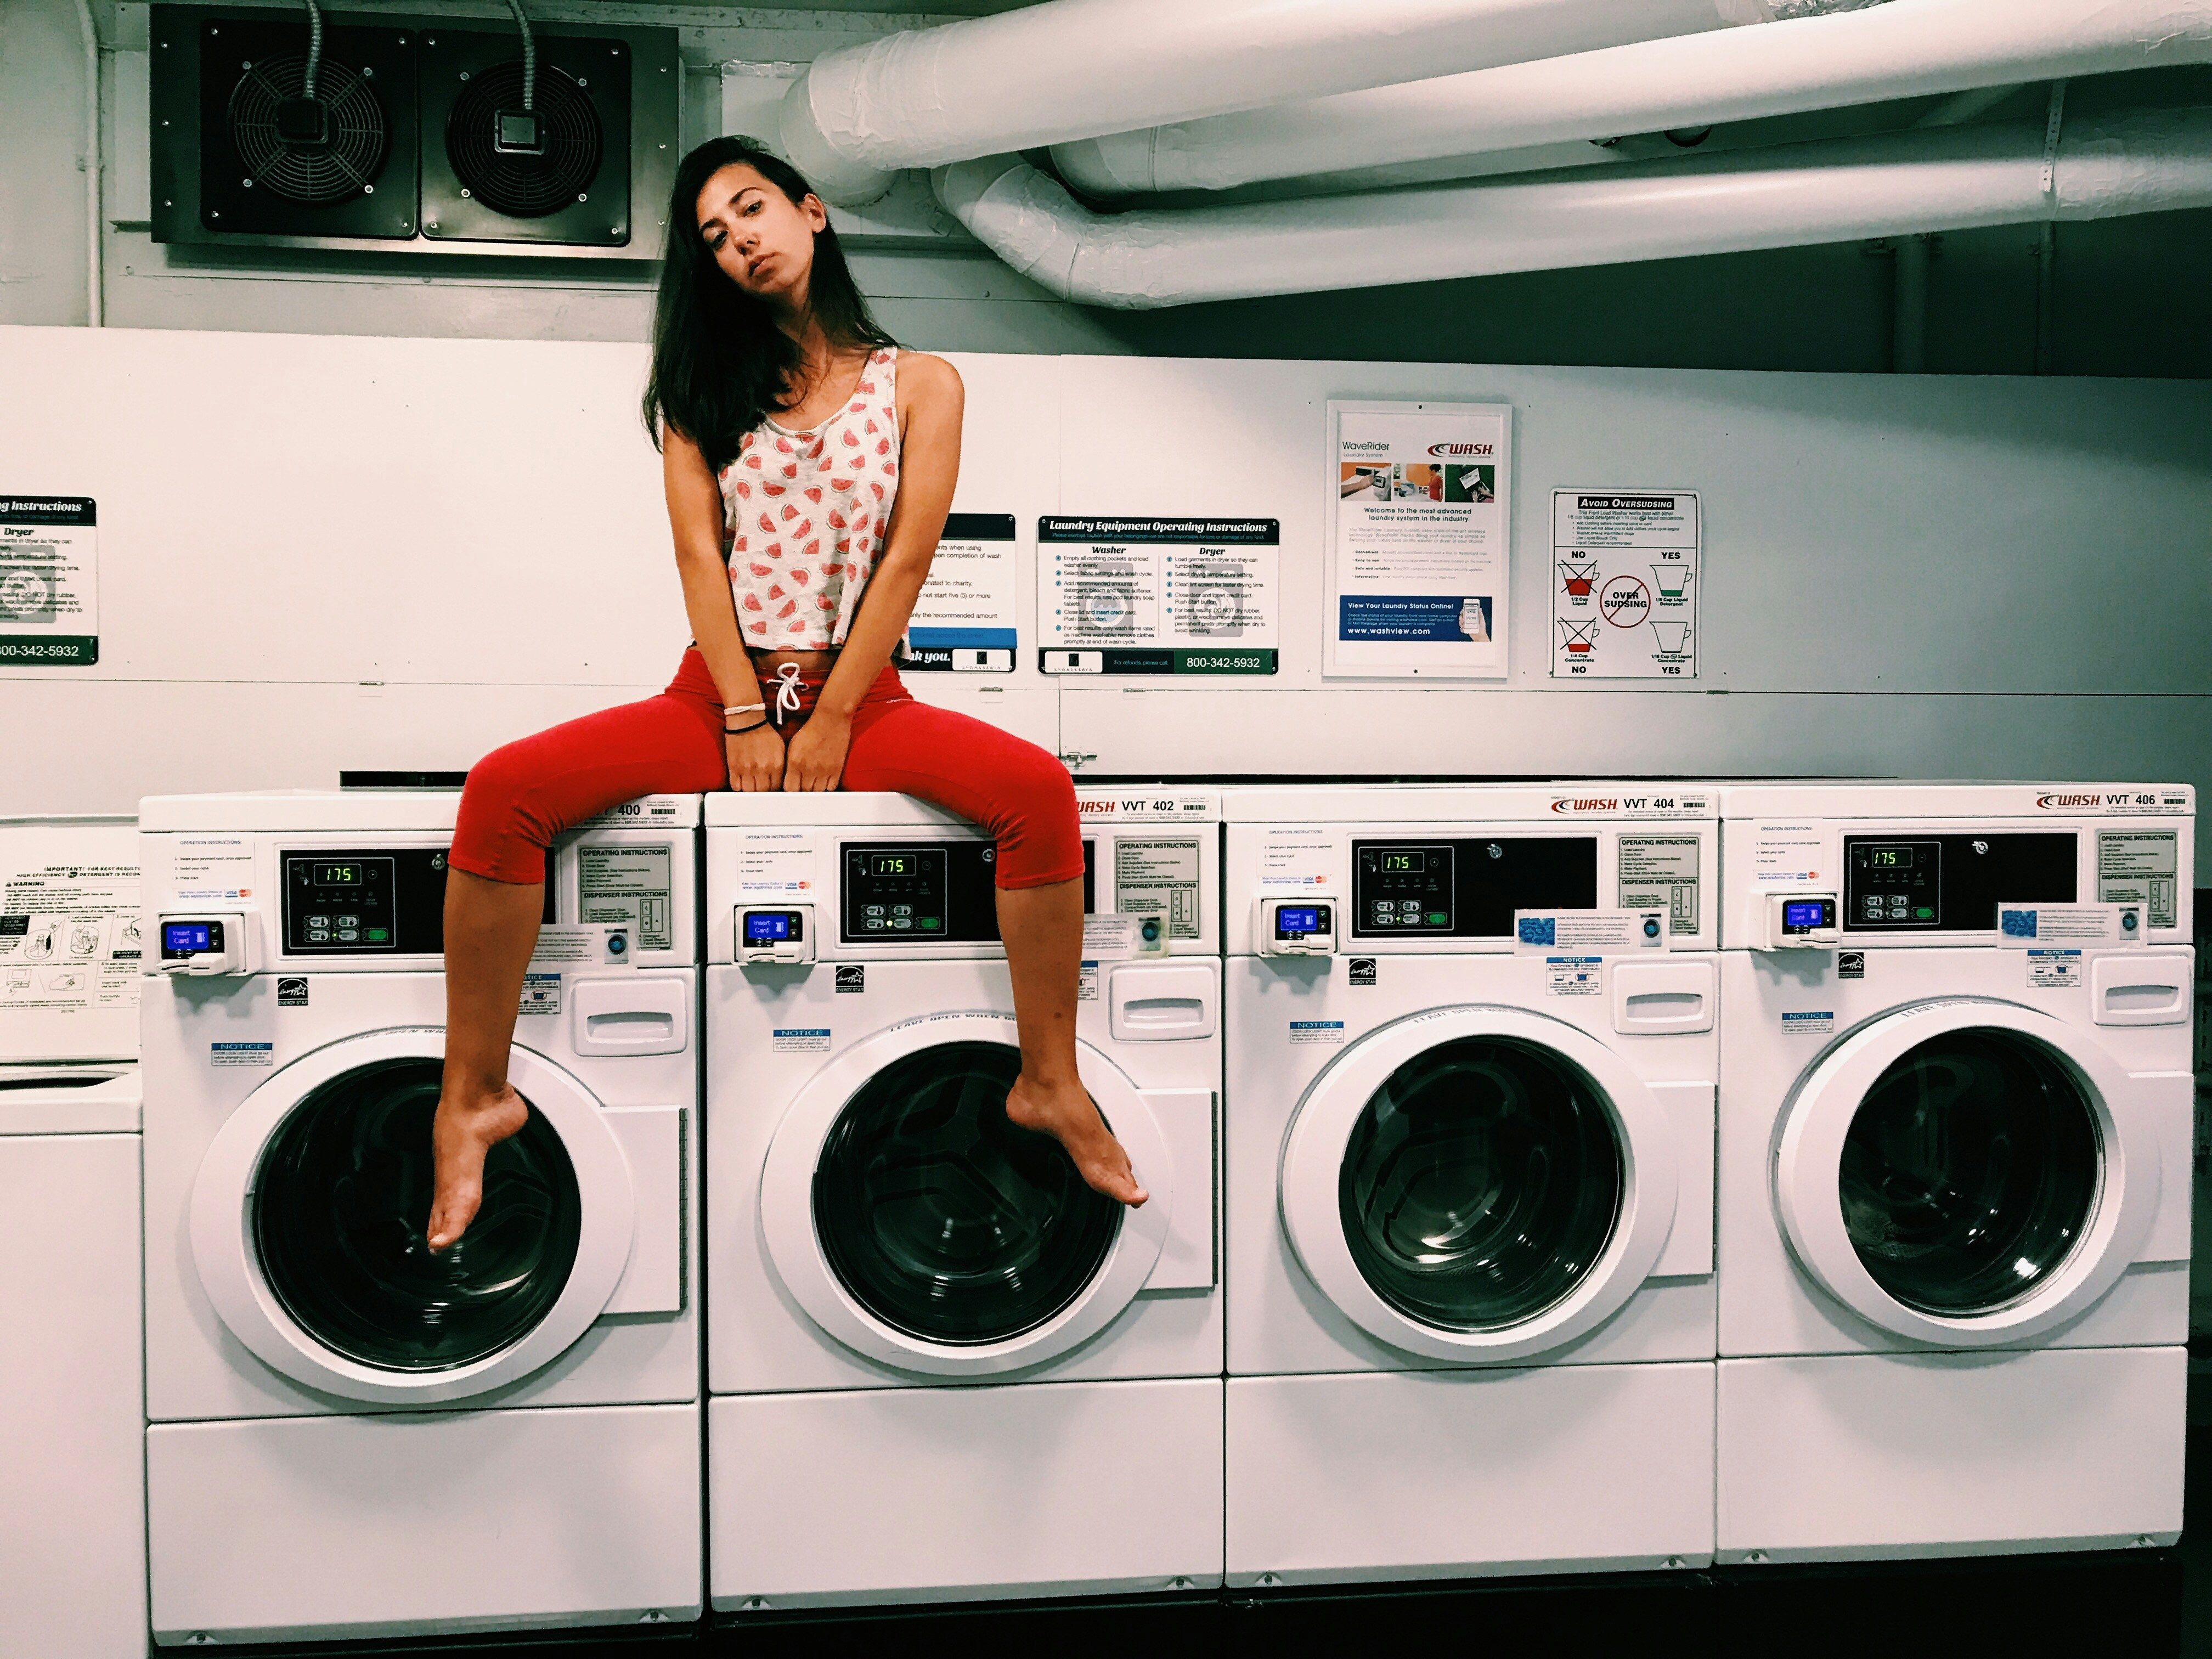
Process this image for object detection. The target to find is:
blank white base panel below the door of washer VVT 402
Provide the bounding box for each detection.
[708,1378,1221,1612]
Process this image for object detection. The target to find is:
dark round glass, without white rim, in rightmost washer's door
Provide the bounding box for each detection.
[1838,1026,2101,1318]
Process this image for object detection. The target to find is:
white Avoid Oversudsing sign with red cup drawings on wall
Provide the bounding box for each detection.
[1550,489,1703,679]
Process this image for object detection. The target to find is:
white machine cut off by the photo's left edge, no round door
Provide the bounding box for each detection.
[0,819,146,1659]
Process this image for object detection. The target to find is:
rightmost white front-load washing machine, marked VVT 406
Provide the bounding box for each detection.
[1719,783,2194,1564]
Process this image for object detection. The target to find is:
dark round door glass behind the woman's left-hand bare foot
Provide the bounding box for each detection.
[248,1057,582,1372]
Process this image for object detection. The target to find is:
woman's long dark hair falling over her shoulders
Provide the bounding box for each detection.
[644,135,896,471]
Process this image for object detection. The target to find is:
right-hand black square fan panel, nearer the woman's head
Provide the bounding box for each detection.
[420,24,633,248]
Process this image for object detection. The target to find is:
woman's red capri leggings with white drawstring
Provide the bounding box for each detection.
[452,646,1084,887]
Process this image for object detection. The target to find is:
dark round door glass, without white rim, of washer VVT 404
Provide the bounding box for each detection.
[1338,1035,1623,1331]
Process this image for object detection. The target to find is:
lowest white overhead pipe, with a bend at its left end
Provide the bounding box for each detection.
[934,109,2212,309]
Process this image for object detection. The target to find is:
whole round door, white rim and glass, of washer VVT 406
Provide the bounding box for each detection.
[1774,1000,2159,1347]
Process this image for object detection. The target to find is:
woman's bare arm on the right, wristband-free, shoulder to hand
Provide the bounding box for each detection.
[787,354,967,789]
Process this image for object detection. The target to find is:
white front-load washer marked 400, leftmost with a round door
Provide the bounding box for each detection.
[139,792,703,1646]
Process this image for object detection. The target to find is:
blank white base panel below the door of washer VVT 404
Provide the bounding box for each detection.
[1228,1361,1714,1588]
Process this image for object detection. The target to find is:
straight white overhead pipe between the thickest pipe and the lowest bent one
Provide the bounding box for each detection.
[1053,0,2212,197]
